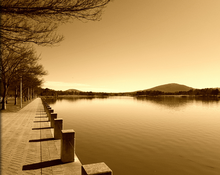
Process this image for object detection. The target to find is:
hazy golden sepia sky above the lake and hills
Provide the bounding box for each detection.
[37,0,220,92]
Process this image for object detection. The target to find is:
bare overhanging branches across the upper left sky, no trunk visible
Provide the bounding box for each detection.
[0,0,110,50]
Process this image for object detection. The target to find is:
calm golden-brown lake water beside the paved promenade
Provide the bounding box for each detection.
[48,97,220,175]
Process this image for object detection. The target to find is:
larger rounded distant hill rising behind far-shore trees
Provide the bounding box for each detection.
[144,83,193,92]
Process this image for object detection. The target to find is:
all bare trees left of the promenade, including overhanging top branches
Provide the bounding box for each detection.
[0,0,110,109]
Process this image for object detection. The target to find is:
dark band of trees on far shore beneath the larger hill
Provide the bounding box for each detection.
[135,88,220,96]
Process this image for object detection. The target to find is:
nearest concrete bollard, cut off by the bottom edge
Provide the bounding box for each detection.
[81,162,113,175]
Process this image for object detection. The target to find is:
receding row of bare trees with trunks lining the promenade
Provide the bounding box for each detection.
[0,45,47,109]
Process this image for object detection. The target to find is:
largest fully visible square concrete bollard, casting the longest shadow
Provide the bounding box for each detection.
[61,129,75,163]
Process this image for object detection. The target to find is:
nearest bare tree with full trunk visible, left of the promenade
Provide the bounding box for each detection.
[0,47,46,109]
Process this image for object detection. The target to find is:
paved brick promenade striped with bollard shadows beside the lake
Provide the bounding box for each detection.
[0,98,81,175]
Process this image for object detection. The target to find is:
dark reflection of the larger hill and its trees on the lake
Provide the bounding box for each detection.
[134,96,219,108]
